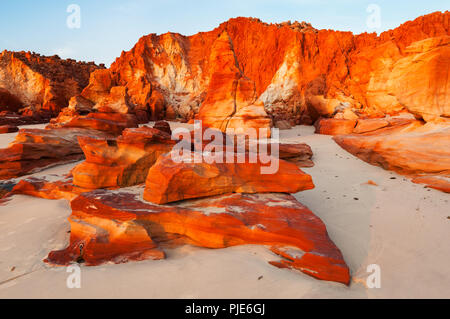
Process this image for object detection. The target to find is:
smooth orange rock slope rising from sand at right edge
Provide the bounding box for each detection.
[334,121,450,188]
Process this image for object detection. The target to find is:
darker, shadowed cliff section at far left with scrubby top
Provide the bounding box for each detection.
[0,51,99,117]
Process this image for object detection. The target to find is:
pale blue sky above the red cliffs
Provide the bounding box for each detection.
[0,0,450,66]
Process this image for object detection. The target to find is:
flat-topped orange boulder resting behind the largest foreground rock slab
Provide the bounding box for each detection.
[144,153,314,204]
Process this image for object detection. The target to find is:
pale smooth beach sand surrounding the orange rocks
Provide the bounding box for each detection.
[0,126,450,298]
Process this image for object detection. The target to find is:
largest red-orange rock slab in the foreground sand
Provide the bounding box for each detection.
[46,189,350,284]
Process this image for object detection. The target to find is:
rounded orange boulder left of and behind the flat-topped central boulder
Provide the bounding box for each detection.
[72,127,175,189]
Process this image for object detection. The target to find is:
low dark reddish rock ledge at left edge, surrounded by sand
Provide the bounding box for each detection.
[0,128,111,180]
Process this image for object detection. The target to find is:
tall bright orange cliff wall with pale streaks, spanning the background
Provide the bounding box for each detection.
[68,11,450,126]
